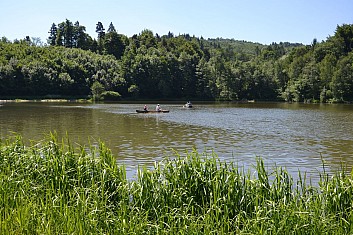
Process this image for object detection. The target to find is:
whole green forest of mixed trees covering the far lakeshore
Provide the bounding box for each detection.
[0,19,353,103]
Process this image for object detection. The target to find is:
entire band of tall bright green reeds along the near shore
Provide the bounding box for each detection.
[0,133,353,234]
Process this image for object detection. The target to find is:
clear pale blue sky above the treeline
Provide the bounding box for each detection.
[0,0,353,44]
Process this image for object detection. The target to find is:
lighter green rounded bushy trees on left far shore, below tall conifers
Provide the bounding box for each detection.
[0,43,124,98]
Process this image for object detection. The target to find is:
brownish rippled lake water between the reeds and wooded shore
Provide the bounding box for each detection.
[0,102,353,180]
